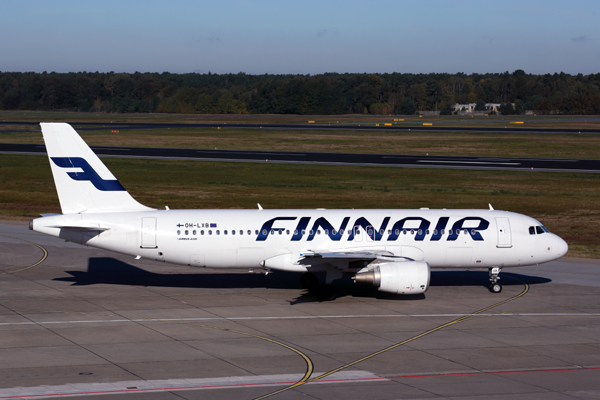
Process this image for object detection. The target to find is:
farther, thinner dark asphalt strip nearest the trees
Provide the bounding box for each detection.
[0,118,600,134]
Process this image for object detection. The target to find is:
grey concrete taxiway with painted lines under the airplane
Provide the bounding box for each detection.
[0,221,600,400]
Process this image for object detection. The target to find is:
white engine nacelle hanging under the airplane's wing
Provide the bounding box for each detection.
[354,261,430,294]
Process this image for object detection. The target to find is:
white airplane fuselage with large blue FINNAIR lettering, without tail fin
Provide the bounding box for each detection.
[32,209,568,271]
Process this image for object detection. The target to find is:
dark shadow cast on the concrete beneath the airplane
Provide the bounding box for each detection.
[54,257,551,304]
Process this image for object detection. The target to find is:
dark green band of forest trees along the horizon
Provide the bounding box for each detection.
[0,70,600,115]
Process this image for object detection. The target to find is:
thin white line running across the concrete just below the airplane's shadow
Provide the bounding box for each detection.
[0,311,600,326]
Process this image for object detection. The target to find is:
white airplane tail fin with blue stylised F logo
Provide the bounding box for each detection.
[40,122,151,214]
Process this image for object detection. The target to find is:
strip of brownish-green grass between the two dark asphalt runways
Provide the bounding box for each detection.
[0,127,600,159]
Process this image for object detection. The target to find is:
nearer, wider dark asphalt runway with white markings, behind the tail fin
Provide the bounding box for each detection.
[0,143,600,173]
